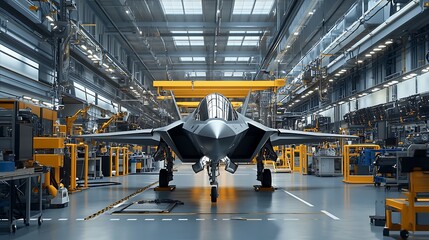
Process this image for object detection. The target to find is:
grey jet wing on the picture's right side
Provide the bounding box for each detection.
[270,129,358,146]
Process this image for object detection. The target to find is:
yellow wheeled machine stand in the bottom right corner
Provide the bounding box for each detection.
[383,171,429,239]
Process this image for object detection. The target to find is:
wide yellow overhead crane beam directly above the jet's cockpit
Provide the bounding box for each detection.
[153,79,285,99]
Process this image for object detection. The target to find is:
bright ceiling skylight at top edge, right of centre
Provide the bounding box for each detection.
[232,0,274,14]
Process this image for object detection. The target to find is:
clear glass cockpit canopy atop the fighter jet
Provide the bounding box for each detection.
[195,93,238,121]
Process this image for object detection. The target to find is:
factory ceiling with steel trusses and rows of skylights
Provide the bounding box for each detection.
[86,0,355,83]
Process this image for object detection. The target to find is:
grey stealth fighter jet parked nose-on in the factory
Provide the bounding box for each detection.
[79,93,356,202]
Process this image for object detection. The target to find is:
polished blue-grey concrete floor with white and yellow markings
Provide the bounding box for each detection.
[0,165,429,240]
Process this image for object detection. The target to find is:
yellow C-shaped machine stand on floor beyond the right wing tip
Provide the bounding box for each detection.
[343,144,380,184]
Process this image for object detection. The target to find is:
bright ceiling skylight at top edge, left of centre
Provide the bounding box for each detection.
[160,0,203,15]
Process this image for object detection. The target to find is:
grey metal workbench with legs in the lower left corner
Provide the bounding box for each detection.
[0,168,42,233]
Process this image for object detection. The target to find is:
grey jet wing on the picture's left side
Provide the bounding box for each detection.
[73,129,161,145]
